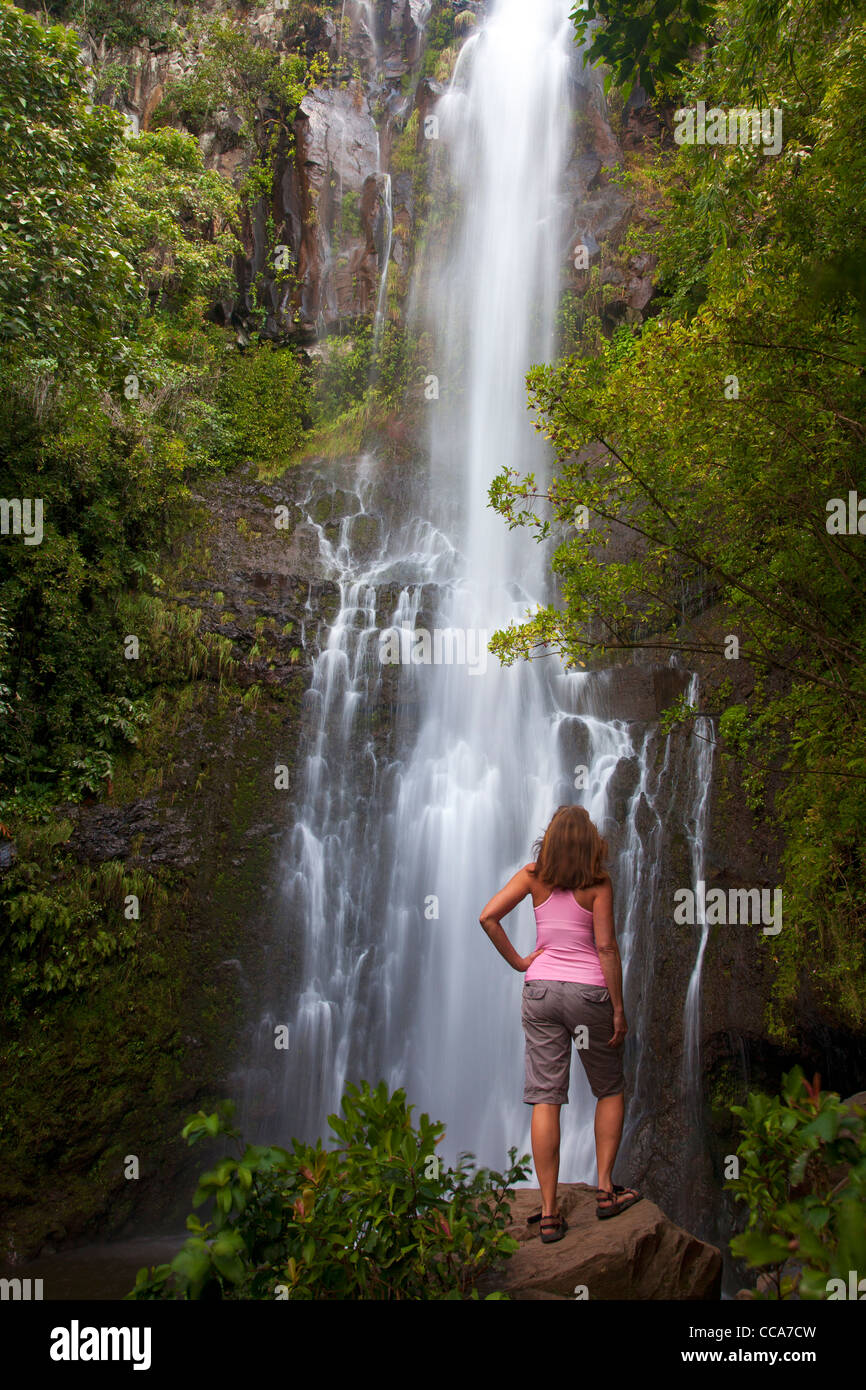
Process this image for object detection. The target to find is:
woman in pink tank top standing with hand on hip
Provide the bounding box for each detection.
[480,806,641,1241]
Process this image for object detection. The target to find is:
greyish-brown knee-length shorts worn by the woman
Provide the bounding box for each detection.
[520,980,624,1105]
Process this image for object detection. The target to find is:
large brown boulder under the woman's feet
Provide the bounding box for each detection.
[478,1183,721,1301]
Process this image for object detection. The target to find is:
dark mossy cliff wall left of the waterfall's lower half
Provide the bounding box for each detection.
[0,477,319,1258]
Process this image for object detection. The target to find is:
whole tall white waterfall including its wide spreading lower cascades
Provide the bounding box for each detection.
[240,0,703,1206]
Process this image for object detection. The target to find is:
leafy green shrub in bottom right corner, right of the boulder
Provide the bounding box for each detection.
[726,1066,866,1298]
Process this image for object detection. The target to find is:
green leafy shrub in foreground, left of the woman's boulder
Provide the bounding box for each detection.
[128,1081,528,1300]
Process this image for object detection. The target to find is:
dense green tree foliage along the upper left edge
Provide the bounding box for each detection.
[0,0,247,813]
